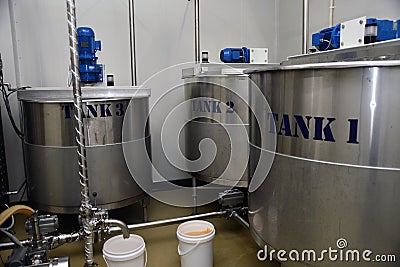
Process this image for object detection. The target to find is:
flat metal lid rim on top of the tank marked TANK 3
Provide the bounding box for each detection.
[18,86,150,102]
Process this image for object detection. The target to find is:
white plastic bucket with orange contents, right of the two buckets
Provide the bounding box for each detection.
[176,220,215,267]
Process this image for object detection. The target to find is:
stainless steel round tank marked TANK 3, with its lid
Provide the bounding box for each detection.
[18,87,151,213]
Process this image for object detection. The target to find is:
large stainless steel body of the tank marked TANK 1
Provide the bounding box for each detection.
[249,61,400,266]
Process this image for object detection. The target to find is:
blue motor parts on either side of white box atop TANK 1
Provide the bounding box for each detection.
[312,18,400,51]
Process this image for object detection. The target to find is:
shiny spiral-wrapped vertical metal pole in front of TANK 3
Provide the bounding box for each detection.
[67,0,96,267]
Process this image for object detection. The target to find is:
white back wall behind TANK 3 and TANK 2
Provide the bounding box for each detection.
[0,0,277,194]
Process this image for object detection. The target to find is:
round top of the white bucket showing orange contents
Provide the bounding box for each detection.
[176,220,215,242]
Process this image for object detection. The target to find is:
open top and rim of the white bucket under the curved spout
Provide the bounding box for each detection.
[103,234,145,256]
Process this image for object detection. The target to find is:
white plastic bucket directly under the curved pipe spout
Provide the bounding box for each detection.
[103,234,147,267]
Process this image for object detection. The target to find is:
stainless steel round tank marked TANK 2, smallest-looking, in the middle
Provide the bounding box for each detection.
[184,67,249,187]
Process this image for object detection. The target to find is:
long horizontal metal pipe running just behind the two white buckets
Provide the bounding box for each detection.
[109,211,227,233]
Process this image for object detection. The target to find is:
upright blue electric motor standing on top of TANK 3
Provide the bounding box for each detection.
[78,27,103,83]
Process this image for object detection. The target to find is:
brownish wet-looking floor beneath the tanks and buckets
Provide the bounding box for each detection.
[0,201,279,267]
